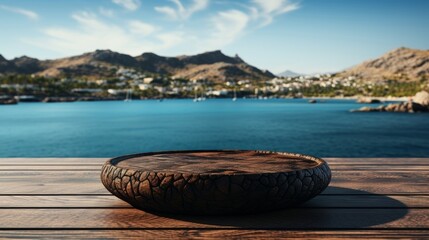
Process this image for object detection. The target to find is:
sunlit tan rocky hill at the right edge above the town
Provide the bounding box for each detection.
[341,47,429,81]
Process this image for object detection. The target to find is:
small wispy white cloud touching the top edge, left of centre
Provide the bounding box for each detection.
[155,0,209,20]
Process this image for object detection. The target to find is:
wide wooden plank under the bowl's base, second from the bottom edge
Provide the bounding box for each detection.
[0,208,429,230]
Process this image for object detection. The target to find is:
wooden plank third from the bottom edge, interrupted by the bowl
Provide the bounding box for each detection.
[0,195,429,208]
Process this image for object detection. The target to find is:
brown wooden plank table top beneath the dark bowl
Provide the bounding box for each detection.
[0,158,429,239]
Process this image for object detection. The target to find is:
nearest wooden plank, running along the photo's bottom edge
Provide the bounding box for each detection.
[0,229,429,239]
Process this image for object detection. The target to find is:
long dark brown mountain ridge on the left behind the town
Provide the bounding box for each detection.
[0,50,274,81]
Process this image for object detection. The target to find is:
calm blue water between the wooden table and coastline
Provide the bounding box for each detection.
[0,99,429,157]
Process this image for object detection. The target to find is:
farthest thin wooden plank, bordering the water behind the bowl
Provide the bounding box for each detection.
[0,158,429,166]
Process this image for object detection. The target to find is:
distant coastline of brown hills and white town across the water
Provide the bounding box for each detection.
[0,47,429,104]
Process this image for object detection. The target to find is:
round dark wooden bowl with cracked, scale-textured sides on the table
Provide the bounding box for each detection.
[101,150,331,215]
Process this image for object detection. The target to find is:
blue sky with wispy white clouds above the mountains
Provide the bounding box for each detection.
[0,0,429,73]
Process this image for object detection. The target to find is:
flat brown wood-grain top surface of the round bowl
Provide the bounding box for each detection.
[112,151,324,175]
